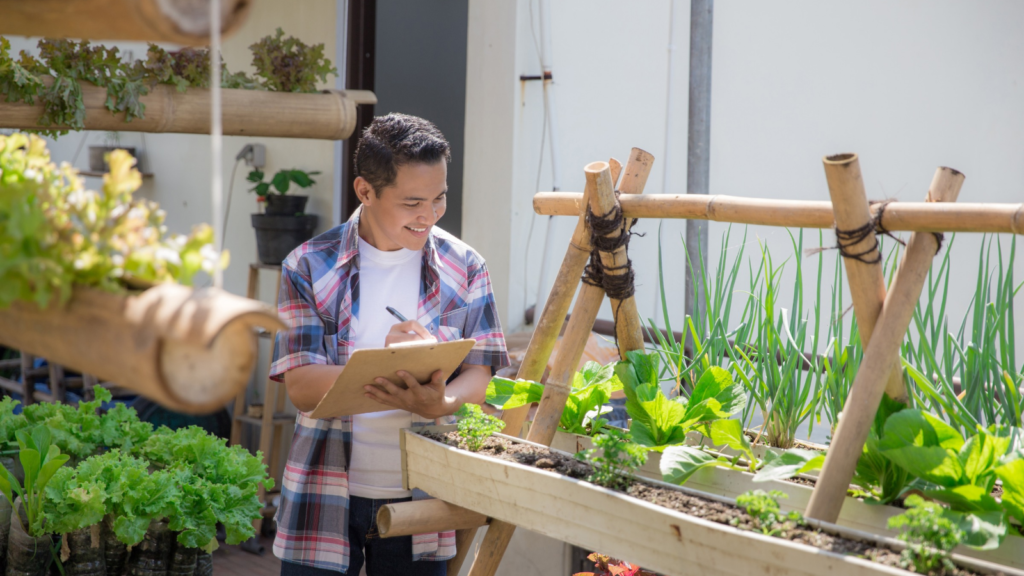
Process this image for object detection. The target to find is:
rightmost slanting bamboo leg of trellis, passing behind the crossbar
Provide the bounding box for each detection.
[806,168,964,522]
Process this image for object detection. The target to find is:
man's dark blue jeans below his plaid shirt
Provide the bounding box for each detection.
[281,496,447,576]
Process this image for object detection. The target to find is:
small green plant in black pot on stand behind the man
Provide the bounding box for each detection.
[247,168,319,264]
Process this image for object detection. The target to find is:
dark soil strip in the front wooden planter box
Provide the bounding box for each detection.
[422,431,998,576]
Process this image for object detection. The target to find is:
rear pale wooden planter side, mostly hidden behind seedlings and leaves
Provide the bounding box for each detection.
[551,430,1024,570]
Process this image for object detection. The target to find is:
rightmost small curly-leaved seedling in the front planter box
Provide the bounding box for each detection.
[889,494,964,574]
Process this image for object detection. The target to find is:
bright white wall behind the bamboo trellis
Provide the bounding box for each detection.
[465,0,1024,363]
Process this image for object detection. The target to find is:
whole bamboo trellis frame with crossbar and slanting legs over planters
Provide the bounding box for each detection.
[385,149,1024,576]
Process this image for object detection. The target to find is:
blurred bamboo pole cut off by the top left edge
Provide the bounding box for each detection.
[0,0,252,45]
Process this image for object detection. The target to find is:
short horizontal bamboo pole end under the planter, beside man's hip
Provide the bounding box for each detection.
[377,500,487,538]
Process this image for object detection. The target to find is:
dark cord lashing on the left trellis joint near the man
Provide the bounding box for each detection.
[582,190,643,335]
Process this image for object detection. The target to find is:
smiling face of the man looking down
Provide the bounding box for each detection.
[355,161,447,251]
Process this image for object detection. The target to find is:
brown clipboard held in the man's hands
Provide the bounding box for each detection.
[309,338,476,418]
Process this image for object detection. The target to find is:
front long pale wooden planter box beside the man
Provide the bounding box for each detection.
[401,427,1024,576]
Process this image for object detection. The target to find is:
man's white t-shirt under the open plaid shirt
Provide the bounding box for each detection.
[348,238,423,498]
